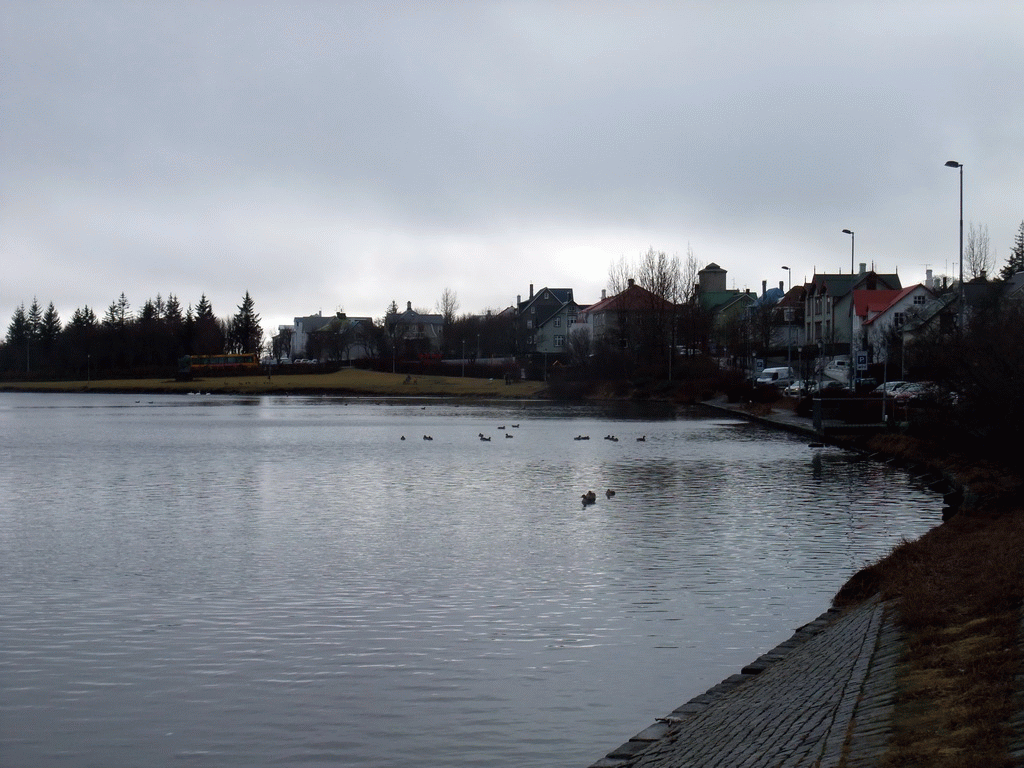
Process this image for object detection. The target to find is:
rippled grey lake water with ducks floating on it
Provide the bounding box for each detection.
[0,394,941,768]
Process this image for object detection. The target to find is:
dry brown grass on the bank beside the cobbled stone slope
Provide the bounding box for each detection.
[837,511,1024,768]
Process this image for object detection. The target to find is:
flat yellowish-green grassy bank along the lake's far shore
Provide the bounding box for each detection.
[0,369,546,399]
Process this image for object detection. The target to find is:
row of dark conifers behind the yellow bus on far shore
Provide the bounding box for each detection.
[0,291,263,379]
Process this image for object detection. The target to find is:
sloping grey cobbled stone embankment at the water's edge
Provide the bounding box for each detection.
[591,601,900,768]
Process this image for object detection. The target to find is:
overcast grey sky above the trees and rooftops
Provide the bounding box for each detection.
[0,0,1024,331]
